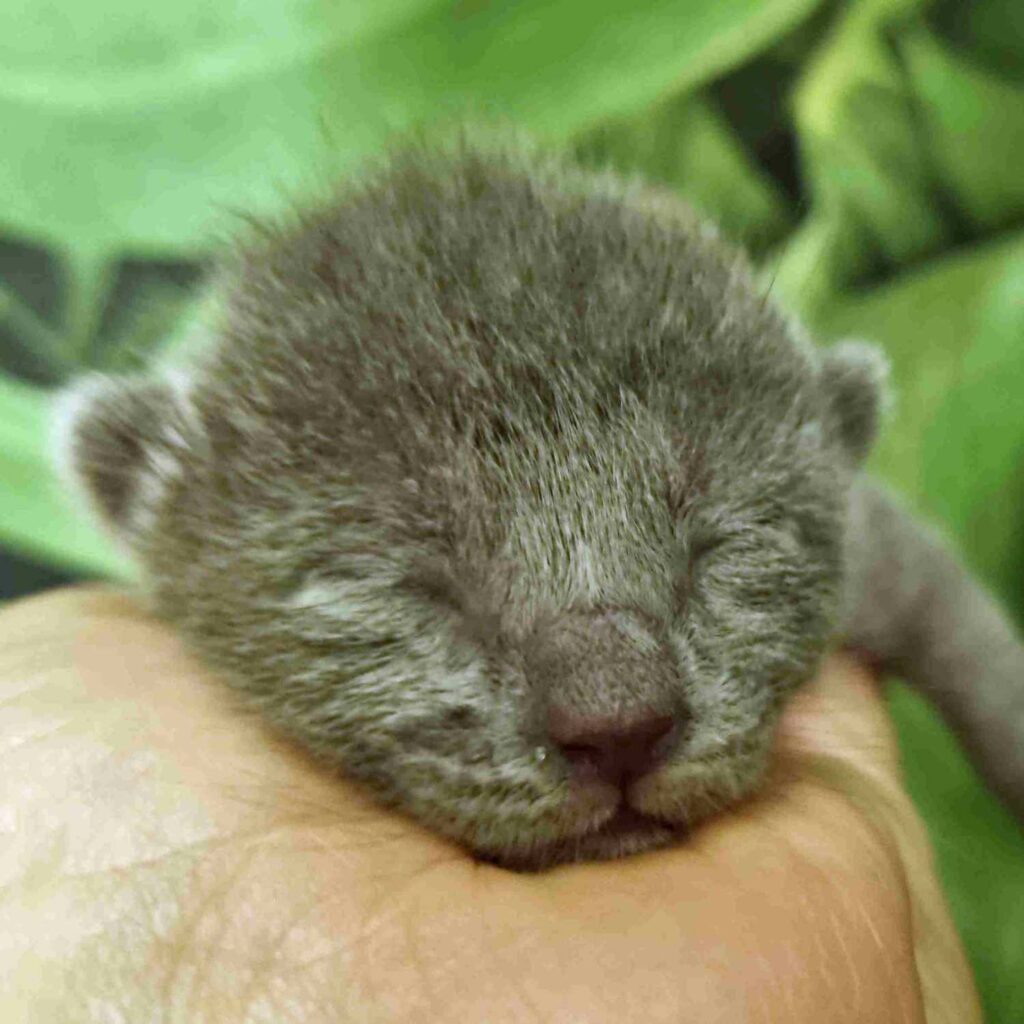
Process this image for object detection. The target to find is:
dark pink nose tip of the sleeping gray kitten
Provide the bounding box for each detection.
[548,705,675,785]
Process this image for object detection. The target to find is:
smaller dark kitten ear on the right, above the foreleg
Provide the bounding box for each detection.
[821,340,889,463]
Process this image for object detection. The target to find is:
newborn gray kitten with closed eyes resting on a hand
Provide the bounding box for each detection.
[54,144,1024,867]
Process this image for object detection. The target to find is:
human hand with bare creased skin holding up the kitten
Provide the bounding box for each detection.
[0,589,980,1024]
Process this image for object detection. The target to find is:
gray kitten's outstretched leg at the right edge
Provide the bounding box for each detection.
[844,481,1024,820]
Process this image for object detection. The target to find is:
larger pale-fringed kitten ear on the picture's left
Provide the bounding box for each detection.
[53,374,193,540]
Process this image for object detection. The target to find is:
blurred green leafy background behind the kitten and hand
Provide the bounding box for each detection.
[0,0,1024,1024]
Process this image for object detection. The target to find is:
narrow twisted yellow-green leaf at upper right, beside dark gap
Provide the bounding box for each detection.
[776,0,953,314]
